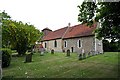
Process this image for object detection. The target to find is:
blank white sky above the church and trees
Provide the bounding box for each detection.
[0,0,83,31]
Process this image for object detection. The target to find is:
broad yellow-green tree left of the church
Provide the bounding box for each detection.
[2,12,42,55]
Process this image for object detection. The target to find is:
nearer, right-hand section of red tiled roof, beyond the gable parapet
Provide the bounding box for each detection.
[64,24,96,38]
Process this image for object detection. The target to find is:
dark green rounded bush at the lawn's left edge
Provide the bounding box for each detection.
[2,49,11,68]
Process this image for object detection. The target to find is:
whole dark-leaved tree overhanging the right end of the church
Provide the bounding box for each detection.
[78,2,120,41]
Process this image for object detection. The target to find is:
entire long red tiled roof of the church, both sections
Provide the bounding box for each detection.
[43,24,96,41]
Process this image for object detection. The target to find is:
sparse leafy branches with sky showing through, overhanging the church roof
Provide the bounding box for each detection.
[78,2,97,25]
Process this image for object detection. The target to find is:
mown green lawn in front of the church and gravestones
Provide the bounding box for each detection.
[3,52,118,78]
